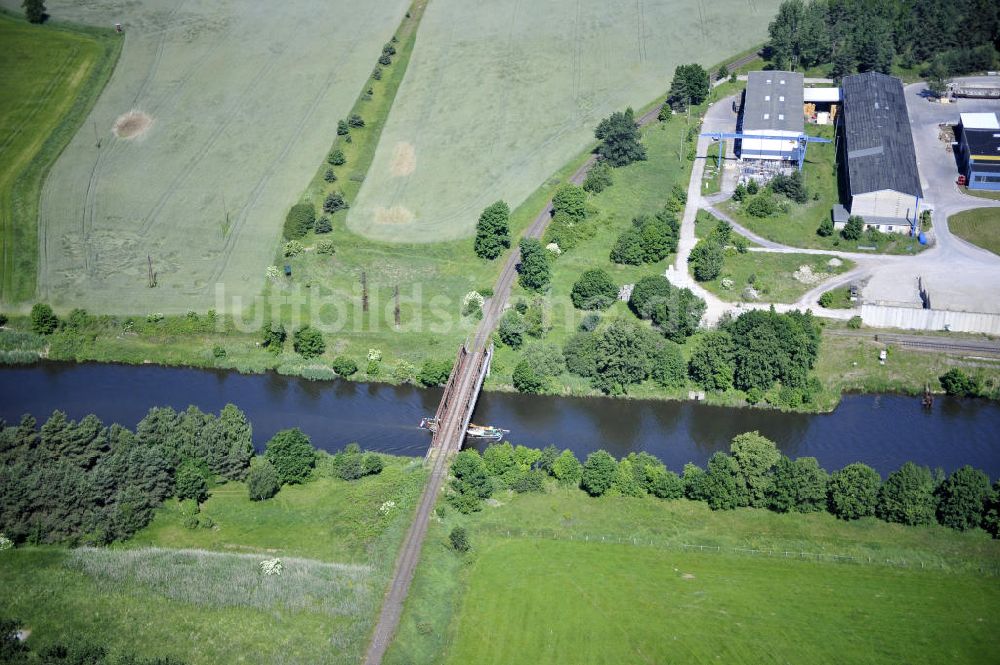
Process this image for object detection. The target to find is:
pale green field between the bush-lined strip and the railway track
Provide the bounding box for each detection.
[348,0,778,243]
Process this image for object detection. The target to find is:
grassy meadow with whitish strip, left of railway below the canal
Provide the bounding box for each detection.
[0,457,426,665]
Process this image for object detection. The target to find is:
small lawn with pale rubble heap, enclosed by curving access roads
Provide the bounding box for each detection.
[701,252,854,303]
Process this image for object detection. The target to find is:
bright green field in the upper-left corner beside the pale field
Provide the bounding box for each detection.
[0,9,121,303]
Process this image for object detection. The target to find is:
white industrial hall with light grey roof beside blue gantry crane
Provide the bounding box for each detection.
[736,71,804,162]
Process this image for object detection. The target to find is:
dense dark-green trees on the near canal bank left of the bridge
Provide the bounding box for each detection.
[0,404,383,545]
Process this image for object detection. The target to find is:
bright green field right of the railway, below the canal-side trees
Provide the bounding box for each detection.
[387,490,1000,664]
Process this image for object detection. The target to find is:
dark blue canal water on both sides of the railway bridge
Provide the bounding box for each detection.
[0,362,1000,478]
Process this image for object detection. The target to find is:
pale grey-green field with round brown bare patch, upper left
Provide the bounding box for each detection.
[14,0,408,314]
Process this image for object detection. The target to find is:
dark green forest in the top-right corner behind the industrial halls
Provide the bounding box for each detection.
[766,0,1000,79]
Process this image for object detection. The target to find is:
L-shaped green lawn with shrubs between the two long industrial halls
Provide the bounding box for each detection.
[720,125,926,254]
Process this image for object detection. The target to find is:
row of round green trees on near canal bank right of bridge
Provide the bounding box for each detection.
[447,432,1000,538]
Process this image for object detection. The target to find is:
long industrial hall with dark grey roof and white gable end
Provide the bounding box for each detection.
[833,72,923,233]
